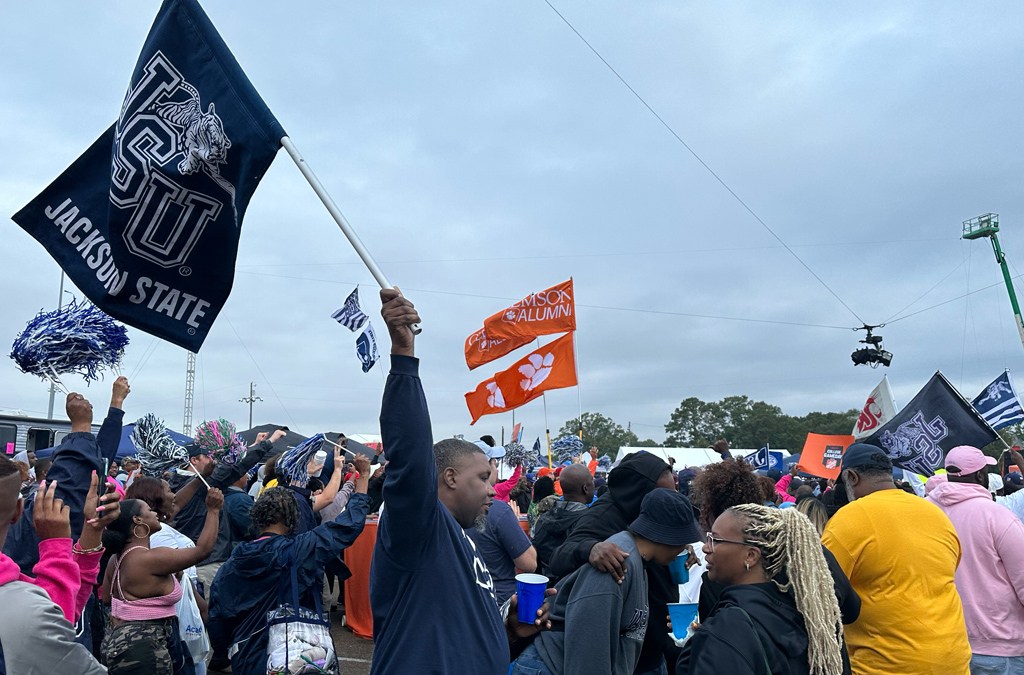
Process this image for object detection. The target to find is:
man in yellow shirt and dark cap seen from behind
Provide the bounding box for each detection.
[822,444,971,675]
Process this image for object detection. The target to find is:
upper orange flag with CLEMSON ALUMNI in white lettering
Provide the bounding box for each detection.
[483,279,575,340]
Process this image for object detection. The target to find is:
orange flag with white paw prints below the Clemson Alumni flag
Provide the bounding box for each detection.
[466,333,577,424]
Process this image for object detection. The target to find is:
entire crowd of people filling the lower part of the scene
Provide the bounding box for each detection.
[0,290,1024,675]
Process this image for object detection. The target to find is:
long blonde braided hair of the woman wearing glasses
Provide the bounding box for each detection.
[729,504,843,675]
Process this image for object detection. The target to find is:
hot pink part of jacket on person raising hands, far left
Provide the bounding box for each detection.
[0,539,103,624]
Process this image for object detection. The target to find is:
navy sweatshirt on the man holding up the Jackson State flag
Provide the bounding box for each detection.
[370,354,509,675]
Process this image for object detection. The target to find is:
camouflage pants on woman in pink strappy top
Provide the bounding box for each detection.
[100,617,196,675]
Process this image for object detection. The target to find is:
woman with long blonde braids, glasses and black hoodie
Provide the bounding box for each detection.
[676,504,846,675]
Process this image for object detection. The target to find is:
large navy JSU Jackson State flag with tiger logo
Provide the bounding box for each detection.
[14,0,285,351]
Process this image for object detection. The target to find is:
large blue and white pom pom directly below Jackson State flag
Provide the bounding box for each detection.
[10,300,128,387]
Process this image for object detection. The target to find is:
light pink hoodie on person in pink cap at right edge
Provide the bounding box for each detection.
[926,482,1024,657]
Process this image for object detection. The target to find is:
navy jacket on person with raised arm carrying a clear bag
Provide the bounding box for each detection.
[208,494,369,675]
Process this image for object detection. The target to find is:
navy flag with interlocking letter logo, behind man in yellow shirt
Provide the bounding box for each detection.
[860,372,998,475]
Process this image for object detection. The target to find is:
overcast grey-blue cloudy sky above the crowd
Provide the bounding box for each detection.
[0,0,1024,448]
